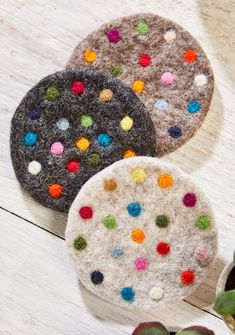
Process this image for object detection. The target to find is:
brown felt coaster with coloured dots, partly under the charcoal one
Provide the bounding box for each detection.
[67,14,214,156]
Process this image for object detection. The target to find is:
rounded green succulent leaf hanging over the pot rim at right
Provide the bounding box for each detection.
[213,290,235,316]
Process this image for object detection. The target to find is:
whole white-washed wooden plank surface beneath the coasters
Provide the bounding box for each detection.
[0,0,235,335]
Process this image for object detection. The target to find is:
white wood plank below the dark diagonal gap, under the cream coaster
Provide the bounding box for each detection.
[0,210,229,335]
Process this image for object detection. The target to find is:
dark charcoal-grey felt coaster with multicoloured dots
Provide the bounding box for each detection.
[11,69,156,211]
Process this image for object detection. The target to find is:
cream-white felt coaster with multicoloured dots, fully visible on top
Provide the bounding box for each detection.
[66,157,217,309]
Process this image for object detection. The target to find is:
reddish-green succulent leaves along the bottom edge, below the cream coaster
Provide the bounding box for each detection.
[132,322,215,335]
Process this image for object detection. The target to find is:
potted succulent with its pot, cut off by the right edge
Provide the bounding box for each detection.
[213,251,235,333]
